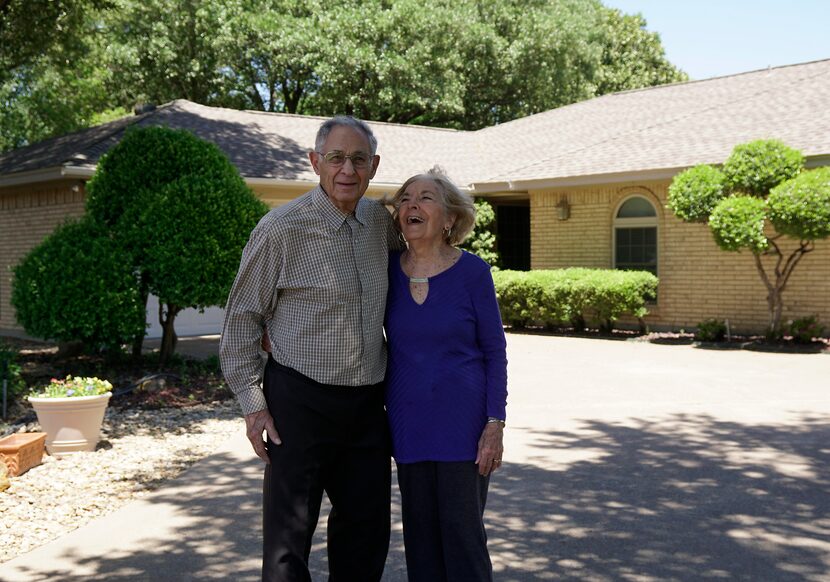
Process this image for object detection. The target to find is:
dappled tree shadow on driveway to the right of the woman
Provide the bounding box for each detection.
[488,415,830,581]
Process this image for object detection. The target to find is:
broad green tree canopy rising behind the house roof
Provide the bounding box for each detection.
[0,0,686,150]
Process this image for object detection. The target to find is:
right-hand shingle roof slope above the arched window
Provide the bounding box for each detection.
[477,60,830,182]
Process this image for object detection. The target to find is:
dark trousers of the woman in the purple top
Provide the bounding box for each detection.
[398,461,493,582]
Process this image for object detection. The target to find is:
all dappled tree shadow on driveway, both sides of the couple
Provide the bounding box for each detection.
[8,414,830,582]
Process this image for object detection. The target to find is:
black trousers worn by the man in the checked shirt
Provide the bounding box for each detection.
[262,358,391,582]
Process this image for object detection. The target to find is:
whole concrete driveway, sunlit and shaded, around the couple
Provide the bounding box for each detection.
[0,334,830,582]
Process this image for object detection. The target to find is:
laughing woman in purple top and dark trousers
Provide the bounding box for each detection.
[386,171,507,582]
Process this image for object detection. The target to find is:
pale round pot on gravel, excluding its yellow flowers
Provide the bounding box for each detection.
[29,392,112,458]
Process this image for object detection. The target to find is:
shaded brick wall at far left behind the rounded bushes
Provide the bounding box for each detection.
[0,180,84,330]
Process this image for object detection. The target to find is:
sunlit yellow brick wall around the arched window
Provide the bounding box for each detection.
[530,181,830,333]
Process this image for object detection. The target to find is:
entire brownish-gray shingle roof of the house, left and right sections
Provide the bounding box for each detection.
[0,60,830,187]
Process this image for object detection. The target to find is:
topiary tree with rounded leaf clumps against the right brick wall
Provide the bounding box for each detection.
[668,140,830,339]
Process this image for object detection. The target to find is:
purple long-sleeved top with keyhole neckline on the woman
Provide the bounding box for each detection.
[386,252,507,463]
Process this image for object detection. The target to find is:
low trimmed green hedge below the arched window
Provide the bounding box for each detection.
[493,268,657,331]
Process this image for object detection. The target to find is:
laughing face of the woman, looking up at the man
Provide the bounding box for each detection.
[398,180,452,242]
